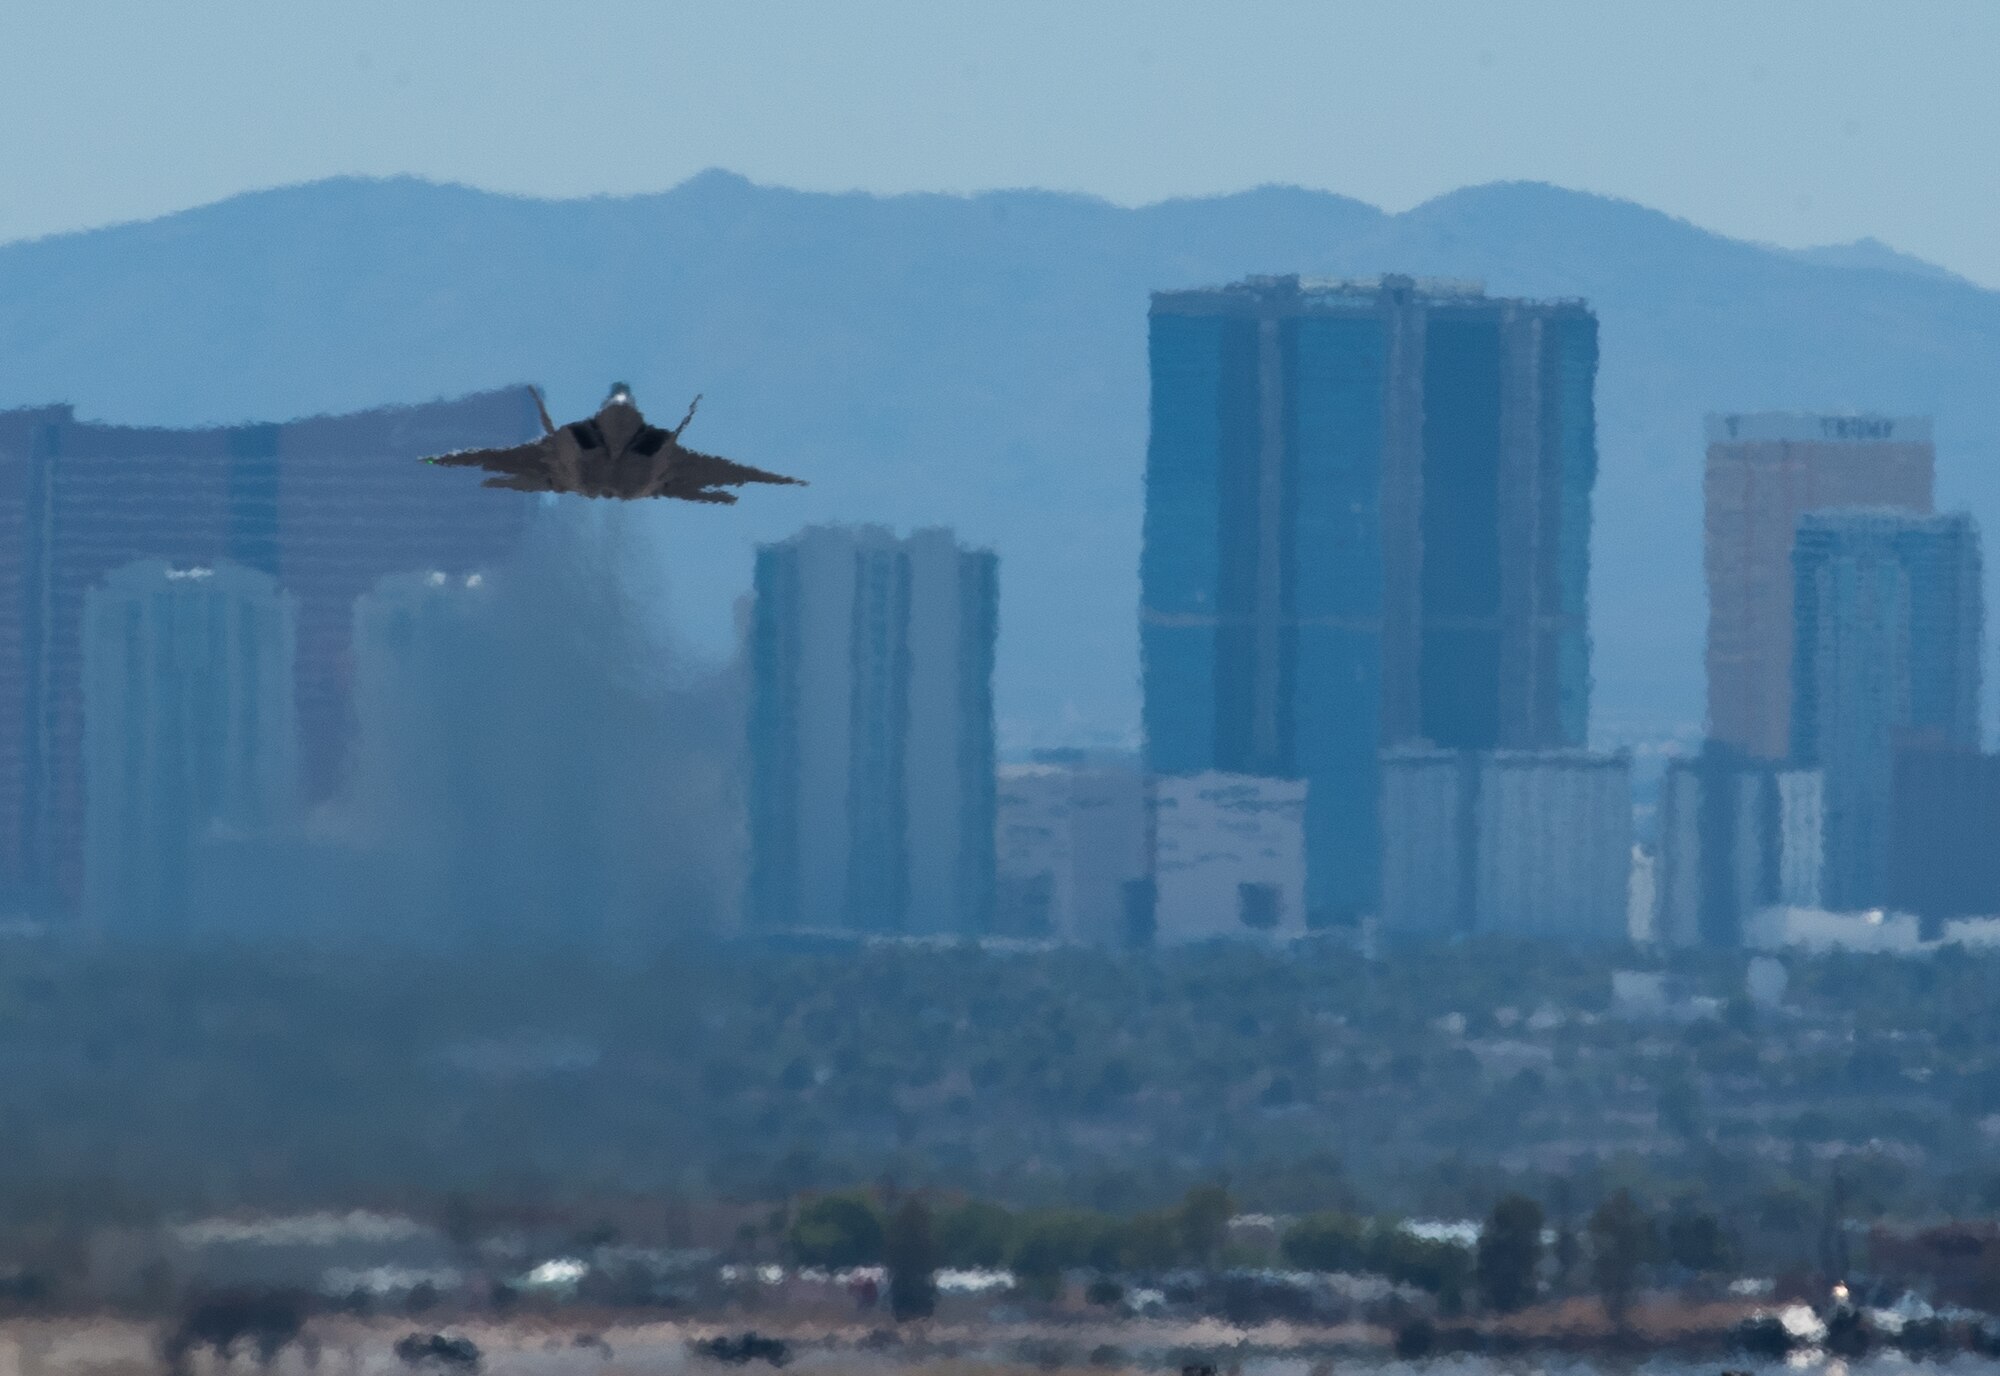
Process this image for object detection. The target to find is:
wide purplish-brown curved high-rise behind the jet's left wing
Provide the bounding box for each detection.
[0,388,540,906]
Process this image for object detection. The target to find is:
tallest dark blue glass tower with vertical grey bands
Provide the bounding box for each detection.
[1140,276,1598,924]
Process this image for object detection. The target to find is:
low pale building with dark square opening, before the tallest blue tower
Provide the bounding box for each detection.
[1150,772,1306,944]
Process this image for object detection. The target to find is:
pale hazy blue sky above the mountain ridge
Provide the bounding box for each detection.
[11,0,2000,286]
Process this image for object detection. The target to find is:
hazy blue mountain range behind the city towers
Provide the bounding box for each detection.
[0,174,2000,746]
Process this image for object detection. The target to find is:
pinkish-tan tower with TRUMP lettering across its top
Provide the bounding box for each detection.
[1702,412,1936,760]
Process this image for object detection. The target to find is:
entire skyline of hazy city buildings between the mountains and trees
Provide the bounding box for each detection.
[0,276,2000,968]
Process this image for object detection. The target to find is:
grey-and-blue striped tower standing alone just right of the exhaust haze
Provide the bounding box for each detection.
[750,526,998,934]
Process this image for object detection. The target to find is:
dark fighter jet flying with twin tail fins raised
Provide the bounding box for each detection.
[424,382,804,502]
